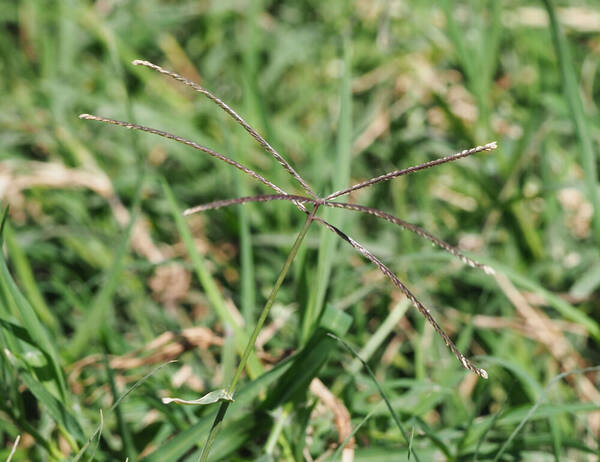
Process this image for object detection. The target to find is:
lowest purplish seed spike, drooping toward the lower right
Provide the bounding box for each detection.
[313,217,488,379]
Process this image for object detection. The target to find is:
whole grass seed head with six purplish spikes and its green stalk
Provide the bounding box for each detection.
[79,60,497,462]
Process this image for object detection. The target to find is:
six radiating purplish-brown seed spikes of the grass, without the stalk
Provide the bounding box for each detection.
[79,60,498,378]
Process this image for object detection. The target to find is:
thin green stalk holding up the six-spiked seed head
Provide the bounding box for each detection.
[199,204,319,462]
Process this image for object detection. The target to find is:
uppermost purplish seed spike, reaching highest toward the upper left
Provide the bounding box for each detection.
[133,59,317,199]
